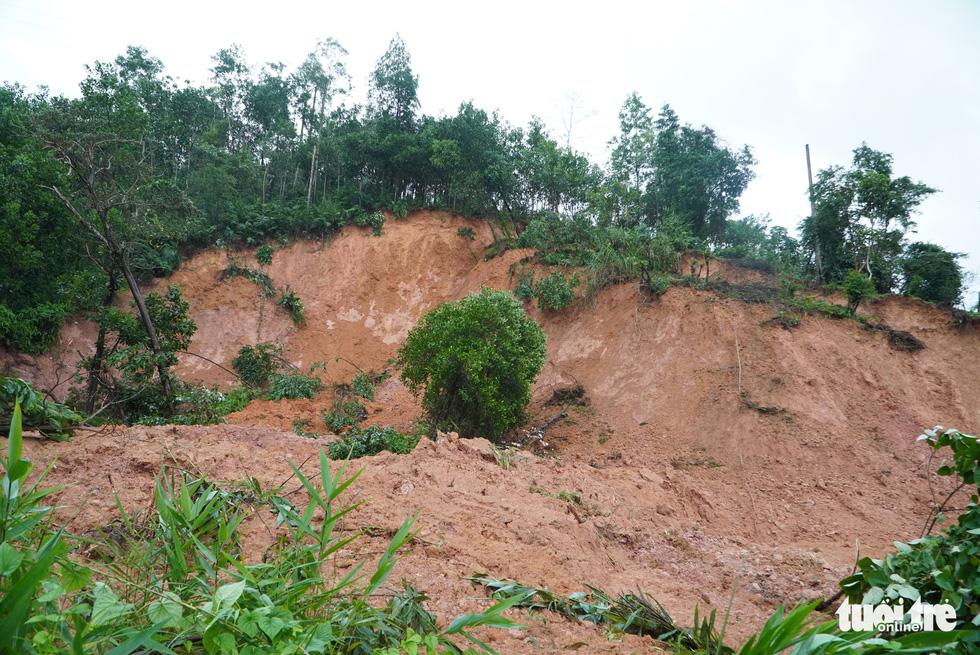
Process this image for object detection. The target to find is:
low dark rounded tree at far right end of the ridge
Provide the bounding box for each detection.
[900,242,965,307]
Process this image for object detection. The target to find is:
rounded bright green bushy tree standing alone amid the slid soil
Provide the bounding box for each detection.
[395,288,545,440]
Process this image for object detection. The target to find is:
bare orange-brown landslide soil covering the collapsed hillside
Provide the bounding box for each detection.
[5,212,980,653]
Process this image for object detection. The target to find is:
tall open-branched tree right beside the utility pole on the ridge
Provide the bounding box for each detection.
[801,143,937,293]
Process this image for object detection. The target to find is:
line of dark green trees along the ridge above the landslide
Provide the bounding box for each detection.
[0,36,961,394]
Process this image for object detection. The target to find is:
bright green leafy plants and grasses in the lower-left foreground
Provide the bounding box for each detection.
[0,408,520,655]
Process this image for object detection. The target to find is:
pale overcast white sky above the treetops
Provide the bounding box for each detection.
[0,0,980,306]
